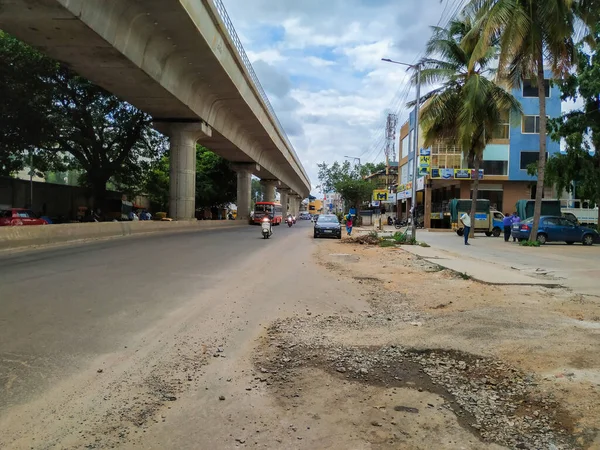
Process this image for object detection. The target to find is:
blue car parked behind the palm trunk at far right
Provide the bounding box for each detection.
[511,216,600,245]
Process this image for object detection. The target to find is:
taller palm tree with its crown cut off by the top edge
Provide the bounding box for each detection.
[464,0,600,240]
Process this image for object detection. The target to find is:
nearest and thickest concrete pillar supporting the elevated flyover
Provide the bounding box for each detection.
[154,122,212,220]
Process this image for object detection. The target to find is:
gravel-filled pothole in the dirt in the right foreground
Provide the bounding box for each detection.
[256,328,586,449]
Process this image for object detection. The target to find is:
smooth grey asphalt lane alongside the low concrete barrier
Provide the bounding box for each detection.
[0,222,312,414]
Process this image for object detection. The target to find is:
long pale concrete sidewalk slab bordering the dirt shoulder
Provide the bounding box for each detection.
[401,245,561,288]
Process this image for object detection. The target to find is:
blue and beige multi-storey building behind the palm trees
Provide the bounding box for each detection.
[397,72,561,228]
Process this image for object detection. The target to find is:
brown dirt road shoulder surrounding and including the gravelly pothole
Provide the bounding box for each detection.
[255,242,600,449]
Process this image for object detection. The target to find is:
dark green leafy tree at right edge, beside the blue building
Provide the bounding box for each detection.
[546,24,600,224]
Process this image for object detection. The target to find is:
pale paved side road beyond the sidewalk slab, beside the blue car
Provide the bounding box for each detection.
[417,230,600,297]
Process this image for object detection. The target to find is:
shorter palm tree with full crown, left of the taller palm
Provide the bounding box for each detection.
[412,16,521,237]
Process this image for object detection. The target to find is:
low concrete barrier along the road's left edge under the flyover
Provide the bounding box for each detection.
[0,220,247,252]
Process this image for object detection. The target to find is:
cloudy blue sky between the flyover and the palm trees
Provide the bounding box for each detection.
[223,0,454,194]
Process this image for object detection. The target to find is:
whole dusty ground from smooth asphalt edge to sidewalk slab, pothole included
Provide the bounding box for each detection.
[0,235,600,450]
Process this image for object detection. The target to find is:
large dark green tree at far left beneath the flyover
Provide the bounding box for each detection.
[0,29,164,207]
